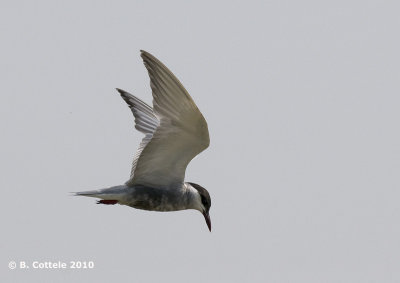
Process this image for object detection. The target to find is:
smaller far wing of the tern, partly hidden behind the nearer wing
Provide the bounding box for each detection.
[117,88,160,179]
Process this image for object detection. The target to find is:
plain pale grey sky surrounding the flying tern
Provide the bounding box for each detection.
[0,0,400,283]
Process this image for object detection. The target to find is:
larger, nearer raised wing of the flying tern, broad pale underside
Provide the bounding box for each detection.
[125,51,210,188]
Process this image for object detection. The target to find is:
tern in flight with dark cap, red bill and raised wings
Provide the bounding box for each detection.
[75,51,211,231]
